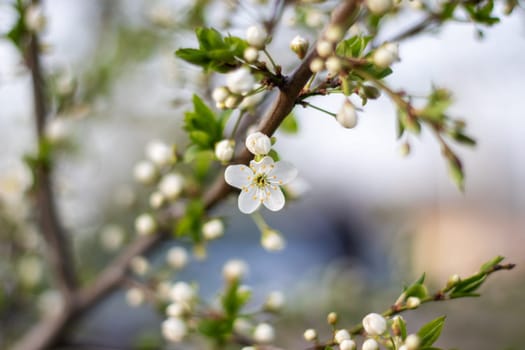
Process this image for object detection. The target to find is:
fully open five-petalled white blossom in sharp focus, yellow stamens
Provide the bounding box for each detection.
[224,157,297,214]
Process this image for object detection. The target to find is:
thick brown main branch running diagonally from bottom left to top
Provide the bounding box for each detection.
[14,0,361,350]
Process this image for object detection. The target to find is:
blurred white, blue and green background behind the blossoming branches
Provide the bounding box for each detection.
[0,0,525,350]
